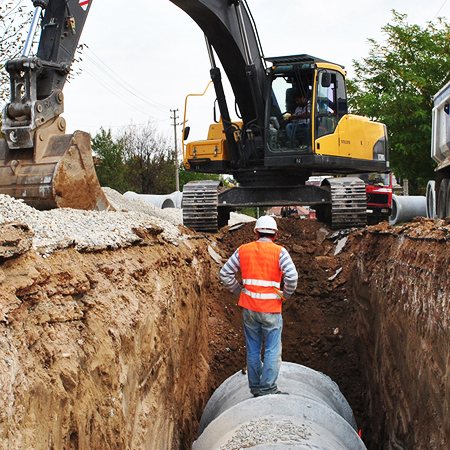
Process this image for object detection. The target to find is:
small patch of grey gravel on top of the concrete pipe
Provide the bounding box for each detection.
[219,417,311,450]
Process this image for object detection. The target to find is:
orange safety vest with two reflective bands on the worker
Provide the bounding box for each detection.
[238,241,283,313]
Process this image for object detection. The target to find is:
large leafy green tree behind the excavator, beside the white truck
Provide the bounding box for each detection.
[348,11,450,192]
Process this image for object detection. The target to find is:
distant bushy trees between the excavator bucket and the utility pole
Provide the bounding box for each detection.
[92,124,175,194]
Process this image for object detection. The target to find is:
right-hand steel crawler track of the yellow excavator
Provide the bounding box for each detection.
[327,177,367,229]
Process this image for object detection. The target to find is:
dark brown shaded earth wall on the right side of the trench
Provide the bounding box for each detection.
[348,231,450,450]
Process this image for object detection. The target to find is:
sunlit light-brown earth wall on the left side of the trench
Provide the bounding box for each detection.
[0,237,215,450]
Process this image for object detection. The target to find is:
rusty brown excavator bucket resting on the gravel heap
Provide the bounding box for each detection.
[0,126,111,211]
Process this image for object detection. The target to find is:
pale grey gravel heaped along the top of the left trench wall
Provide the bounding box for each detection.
[0,194,182,254]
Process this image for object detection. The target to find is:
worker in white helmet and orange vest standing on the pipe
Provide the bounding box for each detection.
[220,216,298,397]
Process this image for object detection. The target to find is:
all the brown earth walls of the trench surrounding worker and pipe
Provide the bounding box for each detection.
[0,219,450,450]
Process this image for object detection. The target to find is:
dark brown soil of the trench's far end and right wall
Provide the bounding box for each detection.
[184,220,450,450]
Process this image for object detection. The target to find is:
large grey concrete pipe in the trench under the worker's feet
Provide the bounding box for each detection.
[192,362,366,450]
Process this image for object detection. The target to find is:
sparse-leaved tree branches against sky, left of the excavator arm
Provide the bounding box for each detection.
[0,0,32,103]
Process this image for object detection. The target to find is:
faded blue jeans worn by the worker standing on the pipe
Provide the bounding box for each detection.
[242,308,283,395]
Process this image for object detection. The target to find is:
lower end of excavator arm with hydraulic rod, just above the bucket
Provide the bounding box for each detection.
[3,0,91,149]
